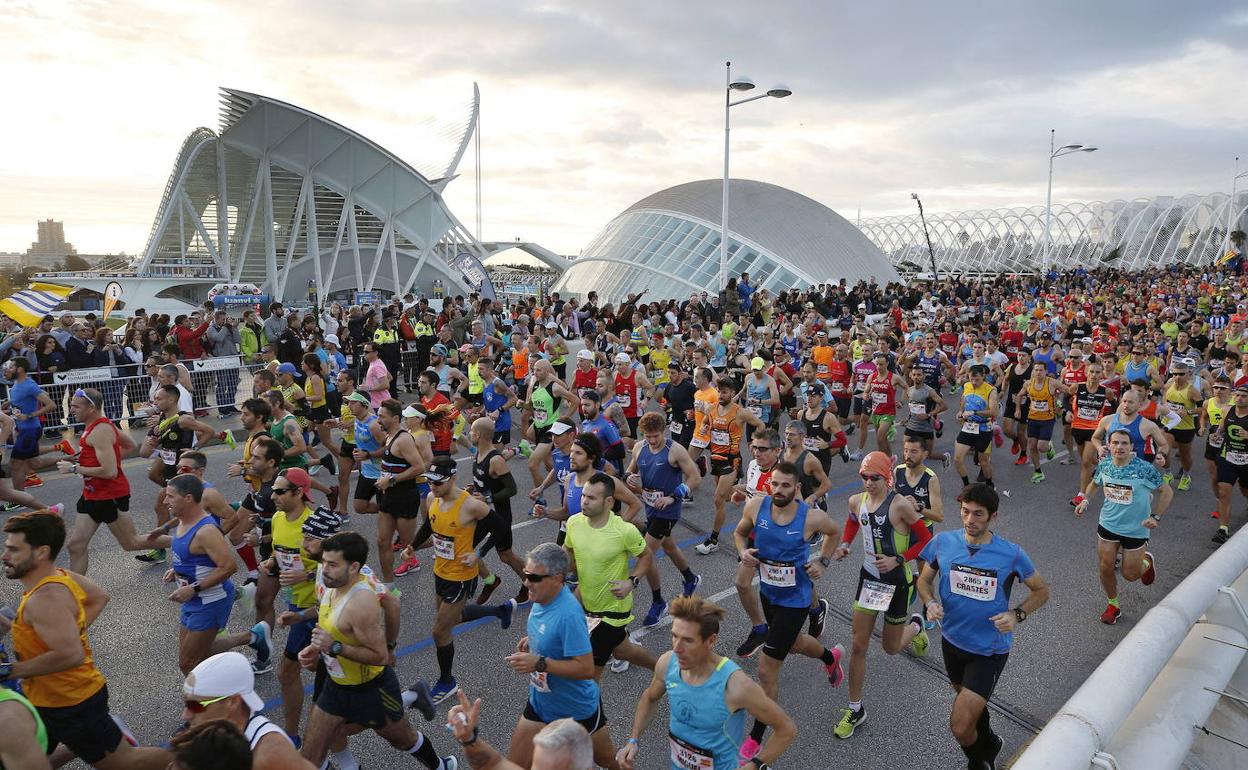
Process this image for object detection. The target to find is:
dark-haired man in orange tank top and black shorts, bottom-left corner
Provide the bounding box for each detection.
[0,512,168,770]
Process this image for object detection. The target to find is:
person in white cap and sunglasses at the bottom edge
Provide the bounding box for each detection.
[182,653,316,770]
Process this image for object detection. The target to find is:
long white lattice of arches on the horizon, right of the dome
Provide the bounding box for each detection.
[859,192,1248,273]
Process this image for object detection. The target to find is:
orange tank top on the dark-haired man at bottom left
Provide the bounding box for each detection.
[11,569,105,709]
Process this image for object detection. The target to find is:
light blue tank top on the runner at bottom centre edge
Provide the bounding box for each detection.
[663,655,745,770]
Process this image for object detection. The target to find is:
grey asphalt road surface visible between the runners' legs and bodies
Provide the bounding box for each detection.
[0,411,1238,770]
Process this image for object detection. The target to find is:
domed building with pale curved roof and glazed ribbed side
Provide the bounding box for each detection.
[552,180,899,302]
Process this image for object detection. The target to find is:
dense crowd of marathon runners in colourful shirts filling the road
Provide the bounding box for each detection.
[0,260,1248,770]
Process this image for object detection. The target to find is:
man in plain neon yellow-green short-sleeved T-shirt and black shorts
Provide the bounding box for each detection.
[563,471,654,680]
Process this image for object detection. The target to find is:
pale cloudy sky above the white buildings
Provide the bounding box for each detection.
[0,0,1248,255]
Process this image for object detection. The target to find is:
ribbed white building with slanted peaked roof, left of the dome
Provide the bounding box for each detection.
[52,86,501,309]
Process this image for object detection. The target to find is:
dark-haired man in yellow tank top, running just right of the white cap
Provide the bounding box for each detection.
[298,532,458,770]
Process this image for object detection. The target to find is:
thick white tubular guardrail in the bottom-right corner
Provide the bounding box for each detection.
[1013,528,1248,770]
